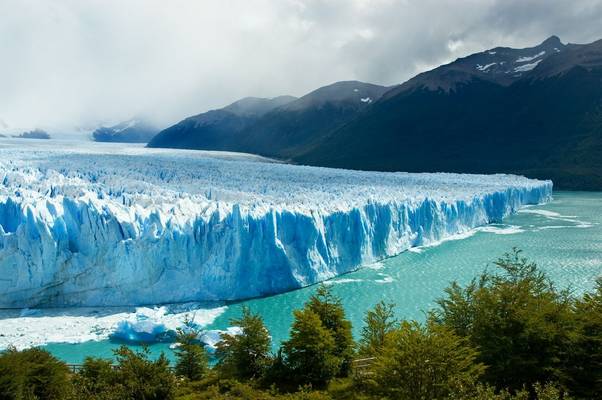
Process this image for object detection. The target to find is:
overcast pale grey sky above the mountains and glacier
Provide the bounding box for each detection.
[0,0,602,133]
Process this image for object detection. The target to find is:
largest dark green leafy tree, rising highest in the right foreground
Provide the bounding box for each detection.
[436,249,574,391]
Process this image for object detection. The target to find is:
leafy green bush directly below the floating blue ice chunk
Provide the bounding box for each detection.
[115,346,176,400]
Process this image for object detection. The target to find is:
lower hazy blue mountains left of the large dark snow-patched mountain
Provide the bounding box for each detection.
[149,81,388,158]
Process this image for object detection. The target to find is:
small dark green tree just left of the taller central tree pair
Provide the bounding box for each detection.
[216,307,271,379]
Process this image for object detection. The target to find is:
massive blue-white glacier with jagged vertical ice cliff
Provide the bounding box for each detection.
[0,141,552,308]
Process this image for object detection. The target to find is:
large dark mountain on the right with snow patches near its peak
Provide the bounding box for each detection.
[291,36,602,190]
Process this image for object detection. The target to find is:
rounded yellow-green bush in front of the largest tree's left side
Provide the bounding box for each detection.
[368,321,485,400]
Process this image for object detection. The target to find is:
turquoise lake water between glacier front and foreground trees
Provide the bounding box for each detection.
[10,192,602,363]
